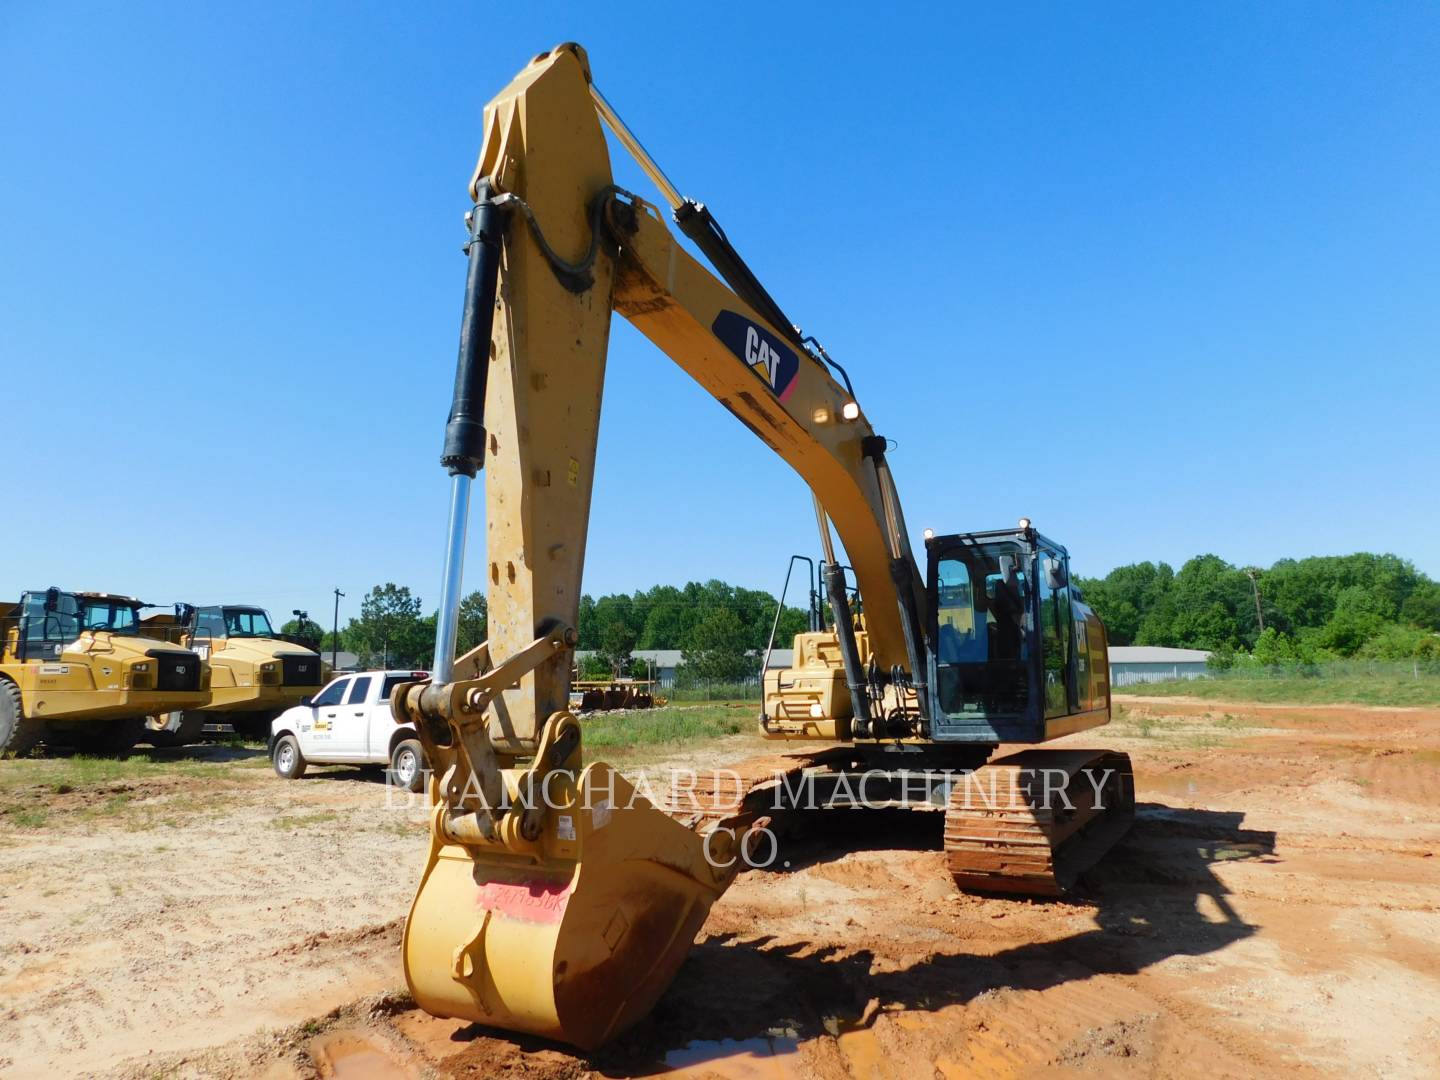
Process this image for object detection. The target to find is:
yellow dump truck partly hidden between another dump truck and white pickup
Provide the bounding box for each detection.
[147,603,330,746]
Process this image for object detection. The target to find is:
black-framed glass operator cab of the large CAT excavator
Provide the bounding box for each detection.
[926,523,1110,743]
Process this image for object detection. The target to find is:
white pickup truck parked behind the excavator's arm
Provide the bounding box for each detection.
[269,671,429,791]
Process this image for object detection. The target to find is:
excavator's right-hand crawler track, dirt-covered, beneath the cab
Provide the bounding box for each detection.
[945,750,1135,896]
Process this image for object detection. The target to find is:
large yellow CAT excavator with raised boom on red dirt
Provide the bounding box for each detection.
[392,45,1133,1048]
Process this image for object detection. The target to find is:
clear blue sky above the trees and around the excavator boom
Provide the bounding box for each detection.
[0,0,1440,624]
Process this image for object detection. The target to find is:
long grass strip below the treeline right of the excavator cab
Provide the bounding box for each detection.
[1115,665,1440,706]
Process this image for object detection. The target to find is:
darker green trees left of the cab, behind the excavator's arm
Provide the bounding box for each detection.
[296,580,805,681]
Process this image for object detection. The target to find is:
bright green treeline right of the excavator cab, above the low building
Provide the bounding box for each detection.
[1076,552,1440,665]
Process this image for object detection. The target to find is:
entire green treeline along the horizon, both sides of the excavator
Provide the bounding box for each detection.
[295,552,1440,683]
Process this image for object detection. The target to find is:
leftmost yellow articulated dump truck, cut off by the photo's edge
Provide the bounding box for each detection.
[0,589,210,756]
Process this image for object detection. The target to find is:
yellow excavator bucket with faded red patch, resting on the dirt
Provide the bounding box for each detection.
[403,763,734,1050]
